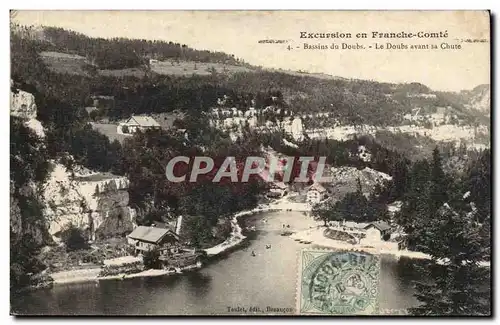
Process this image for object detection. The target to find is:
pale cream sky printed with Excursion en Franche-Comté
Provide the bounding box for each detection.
[14,11,490,90]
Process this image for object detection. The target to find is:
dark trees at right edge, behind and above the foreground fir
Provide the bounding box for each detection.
[397,149,491,250]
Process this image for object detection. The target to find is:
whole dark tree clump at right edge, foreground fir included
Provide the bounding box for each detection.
[396,149,491,315]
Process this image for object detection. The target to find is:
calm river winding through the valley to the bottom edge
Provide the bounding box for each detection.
[11,212,417,315]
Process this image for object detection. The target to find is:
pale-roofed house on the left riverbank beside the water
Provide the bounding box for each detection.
[127,226,179,253]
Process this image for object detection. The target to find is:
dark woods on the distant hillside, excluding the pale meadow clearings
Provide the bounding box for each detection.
[11,23,480,125]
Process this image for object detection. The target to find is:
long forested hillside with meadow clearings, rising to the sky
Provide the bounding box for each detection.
[11,23,484,126]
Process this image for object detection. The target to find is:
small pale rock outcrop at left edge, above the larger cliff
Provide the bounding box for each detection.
[10,89,45,137]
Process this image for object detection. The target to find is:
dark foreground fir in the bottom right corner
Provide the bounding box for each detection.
[410,207,491,316]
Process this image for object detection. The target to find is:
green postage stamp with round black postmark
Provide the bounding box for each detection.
[297,249,380,315]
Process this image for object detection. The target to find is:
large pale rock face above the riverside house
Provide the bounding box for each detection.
[44,164,135,241]
